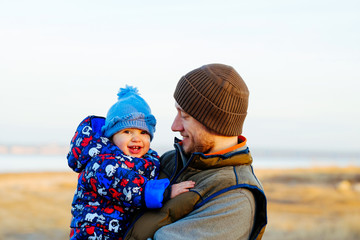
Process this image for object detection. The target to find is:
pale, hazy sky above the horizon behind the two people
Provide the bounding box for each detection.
[0,0,360,152]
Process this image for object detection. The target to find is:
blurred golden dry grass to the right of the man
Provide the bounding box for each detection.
[256,168,360,240]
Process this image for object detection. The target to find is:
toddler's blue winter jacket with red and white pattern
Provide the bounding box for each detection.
[67,116,169,236]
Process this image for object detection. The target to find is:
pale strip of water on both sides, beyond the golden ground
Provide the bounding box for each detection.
[0,154,360,173]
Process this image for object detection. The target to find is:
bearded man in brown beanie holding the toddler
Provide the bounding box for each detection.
[125,64,267,240]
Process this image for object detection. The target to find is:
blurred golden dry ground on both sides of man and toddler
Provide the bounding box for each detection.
[0,167,360,240]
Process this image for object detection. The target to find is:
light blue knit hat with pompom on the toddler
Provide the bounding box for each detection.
[101,85,156,140]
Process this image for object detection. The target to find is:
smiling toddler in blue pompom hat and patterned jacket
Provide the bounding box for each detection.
[67,86,194,240]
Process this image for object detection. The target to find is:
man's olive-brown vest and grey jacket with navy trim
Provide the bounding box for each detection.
[124,139,267,240]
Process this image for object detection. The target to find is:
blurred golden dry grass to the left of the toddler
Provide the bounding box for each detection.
[0,173,77,240]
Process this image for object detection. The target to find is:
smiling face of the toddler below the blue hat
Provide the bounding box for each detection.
[113,128,150,157]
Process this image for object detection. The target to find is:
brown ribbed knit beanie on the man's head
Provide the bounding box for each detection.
[174,64,249,136]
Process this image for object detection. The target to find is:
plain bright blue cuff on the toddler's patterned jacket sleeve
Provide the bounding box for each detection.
[145,178,170,208]
